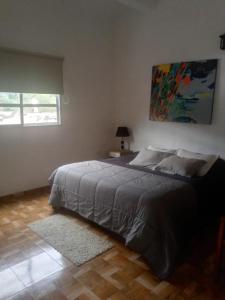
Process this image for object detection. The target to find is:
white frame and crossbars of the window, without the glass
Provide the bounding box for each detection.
[0,92,61,128]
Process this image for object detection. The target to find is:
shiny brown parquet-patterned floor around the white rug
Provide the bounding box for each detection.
[0,191,225,300]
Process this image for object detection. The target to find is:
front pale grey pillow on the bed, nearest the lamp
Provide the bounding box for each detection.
[129,149,171,167]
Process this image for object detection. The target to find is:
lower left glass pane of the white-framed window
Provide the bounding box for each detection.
[0,107,20,125]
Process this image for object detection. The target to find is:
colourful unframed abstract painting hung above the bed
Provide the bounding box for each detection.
[150,59,217,124]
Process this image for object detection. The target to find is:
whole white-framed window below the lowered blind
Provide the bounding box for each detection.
[0,92,60,126]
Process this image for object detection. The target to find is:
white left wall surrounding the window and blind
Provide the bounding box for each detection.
[0,0,118,196]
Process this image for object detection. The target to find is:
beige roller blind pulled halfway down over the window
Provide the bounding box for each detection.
[0,49,63,94]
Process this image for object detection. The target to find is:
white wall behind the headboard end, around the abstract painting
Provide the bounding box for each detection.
[114,0,225,157]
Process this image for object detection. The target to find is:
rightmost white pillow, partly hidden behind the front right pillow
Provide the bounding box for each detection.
[177,149,218,176]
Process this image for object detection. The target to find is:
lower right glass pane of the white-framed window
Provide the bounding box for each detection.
[23,107,58,124]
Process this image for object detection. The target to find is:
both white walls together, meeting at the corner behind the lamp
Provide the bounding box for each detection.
[0,0,225,196]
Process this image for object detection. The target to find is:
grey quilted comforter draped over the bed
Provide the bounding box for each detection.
[49,161,197,278]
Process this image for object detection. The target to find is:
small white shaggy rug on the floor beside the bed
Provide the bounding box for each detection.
[28,214,113,266]
